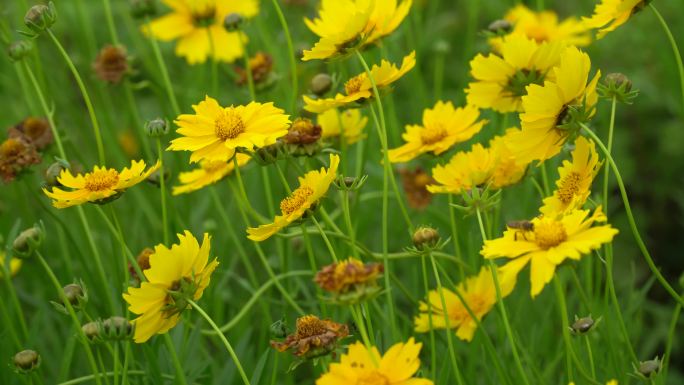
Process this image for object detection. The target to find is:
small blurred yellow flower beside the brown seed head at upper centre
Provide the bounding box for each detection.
[316,108,368,144]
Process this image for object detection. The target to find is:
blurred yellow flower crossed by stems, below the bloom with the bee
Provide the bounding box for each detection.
[414,266,518,341]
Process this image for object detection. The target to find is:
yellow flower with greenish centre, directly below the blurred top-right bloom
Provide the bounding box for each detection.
[465,35,565,113]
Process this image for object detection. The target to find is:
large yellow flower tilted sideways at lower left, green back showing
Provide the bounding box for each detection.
[123,230,219,343]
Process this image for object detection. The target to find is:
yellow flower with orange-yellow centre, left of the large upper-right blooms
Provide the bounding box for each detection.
[389,101,487,163]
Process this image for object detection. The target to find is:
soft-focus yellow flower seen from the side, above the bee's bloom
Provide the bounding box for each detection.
[427,129,527,194]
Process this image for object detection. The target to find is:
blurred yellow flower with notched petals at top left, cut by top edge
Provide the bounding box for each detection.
[142,0,259,64]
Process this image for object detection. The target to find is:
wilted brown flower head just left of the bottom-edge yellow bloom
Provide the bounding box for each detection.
[271,315,349,358]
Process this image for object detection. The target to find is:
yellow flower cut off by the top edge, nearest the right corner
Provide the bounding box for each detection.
[583,0,646,39]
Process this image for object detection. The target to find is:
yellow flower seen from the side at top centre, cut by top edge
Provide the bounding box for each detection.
[302,0,412,61]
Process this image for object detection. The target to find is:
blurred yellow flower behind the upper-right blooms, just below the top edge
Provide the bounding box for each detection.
[489,4,591,51]
